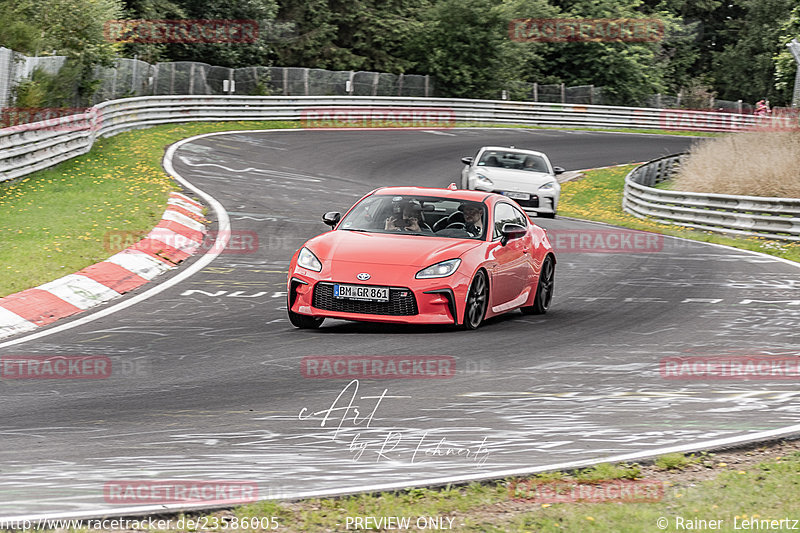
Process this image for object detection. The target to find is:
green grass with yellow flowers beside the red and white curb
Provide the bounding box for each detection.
[0,118,297,297]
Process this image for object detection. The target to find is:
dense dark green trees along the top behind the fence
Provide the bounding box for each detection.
[0,0,800,105]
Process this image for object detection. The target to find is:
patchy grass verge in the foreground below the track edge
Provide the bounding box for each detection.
[14,441,800,533]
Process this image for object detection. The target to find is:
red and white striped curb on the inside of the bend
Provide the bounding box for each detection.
[0,193,206,339]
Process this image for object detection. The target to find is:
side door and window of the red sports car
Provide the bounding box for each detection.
[491,202,532,312]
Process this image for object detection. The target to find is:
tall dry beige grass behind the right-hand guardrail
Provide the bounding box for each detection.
[670,131,800,198]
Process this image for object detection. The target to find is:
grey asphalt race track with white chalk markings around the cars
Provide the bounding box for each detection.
[0,129,800,517]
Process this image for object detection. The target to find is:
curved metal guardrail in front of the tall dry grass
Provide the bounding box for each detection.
[622,154,800,241]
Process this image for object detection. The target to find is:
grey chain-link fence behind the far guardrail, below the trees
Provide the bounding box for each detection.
[0,43,788,113]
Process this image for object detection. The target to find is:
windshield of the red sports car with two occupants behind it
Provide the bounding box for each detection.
[337,194,486,239]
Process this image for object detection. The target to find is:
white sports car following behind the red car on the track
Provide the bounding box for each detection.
[461,146,564,218]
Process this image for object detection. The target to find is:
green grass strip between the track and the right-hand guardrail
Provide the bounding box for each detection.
[558,165,800,261]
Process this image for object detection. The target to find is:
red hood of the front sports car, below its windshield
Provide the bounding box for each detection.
[306,230,482,269]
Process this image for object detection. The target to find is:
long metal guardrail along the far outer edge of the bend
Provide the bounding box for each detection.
[0,96,796,185]
